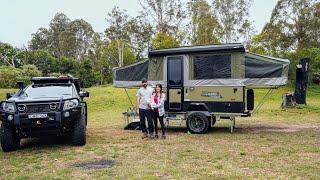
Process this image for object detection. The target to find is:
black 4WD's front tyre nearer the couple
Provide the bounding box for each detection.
[72,116,86,146]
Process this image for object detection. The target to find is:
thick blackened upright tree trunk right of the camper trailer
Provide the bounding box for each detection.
[294,58,311,104]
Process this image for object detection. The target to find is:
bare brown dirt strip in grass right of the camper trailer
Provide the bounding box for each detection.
[243,124,320,133]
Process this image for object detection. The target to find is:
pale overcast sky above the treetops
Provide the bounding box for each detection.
[0,0,277,47]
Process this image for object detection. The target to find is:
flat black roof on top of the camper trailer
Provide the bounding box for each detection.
[149,43,245,57]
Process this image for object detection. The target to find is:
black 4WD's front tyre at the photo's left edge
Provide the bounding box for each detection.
[0,123,20,152]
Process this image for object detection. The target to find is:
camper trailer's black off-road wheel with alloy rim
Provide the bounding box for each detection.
[187,112,210,134]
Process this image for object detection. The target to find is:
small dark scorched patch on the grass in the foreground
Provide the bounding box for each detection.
[75,159,115,169]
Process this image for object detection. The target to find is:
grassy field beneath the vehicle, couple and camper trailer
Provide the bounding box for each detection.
[0,86,320,179]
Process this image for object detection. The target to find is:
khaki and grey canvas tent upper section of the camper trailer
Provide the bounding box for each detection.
[113,44,290,88]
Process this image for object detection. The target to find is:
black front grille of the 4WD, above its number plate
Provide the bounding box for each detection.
[17,103,59,113]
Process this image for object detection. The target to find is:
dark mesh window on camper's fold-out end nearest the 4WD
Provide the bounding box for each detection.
[116,61,149,81]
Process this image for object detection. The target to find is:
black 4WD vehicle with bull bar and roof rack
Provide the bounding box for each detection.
[0,76,89,152]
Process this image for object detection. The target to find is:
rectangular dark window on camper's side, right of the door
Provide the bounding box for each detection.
[193,55,231,79]
